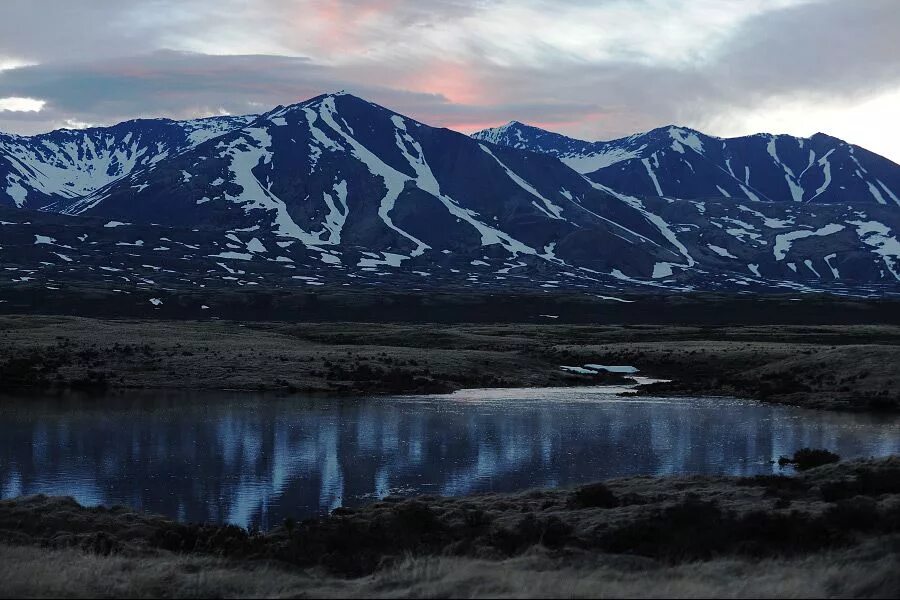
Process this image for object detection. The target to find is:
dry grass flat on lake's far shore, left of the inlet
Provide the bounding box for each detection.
[0,316,604,394]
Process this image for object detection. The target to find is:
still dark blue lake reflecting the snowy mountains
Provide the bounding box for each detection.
[0,387,900,529]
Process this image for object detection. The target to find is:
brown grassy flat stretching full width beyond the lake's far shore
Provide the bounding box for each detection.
[0,315,900,411]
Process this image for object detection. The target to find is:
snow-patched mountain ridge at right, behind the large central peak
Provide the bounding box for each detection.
[472,121,900,208]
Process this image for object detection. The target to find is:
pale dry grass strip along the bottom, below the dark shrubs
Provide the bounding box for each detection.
[0,542,900,598]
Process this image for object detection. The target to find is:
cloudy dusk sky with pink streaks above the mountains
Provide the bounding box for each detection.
[0,0,900,162]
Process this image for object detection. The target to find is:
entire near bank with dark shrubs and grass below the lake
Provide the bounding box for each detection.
[0,457,900,597]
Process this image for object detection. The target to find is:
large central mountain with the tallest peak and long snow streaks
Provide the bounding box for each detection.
[40,94,684,273]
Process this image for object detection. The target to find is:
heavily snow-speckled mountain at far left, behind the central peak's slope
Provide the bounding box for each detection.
[0,117,252,208]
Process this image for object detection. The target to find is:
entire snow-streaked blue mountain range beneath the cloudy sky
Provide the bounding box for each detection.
[0,93,900,295]
